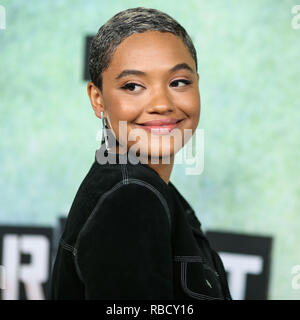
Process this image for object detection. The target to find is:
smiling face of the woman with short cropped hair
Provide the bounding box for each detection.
[88,31,200,159]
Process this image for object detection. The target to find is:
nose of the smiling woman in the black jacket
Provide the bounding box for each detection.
[147,88,175,113]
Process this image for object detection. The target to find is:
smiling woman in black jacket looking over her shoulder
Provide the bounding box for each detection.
[51,7,231,300]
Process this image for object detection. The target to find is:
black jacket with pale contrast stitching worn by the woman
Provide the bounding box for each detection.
[50,145,231,300]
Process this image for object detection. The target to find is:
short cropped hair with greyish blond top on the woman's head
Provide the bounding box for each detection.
[89,7,198,91]
